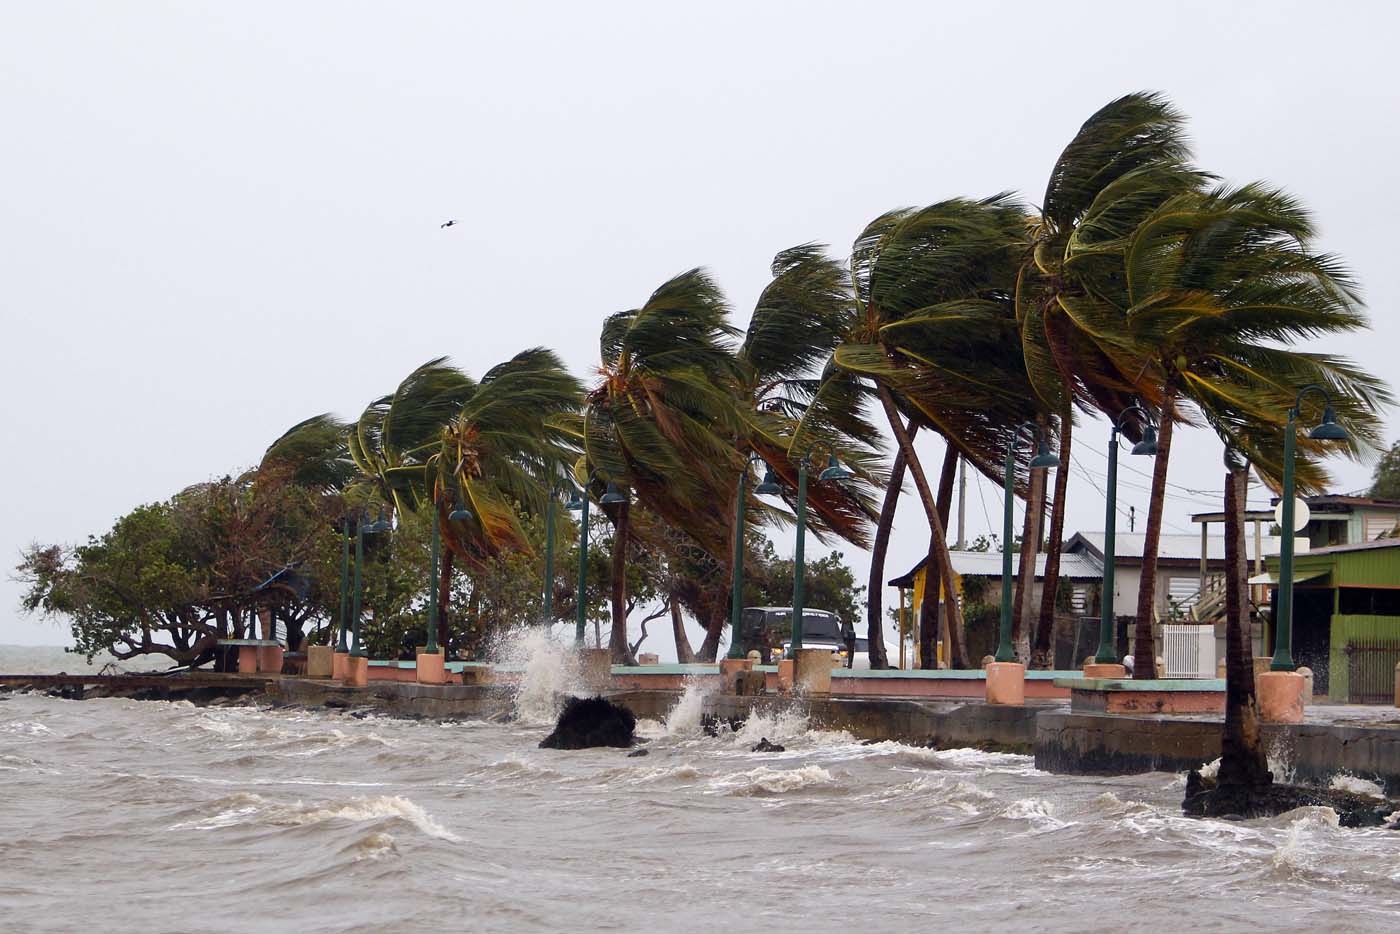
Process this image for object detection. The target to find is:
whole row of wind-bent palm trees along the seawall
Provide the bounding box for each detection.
[266,94,1389,672]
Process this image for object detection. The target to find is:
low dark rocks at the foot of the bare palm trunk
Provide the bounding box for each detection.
[1182,769,1400,829]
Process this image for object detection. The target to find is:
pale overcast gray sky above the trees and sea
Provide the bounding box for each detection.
[0,0,1400,654]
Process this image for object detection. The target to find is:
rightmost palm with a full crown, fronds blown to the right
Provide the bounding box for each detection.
[1100,185,1389,678]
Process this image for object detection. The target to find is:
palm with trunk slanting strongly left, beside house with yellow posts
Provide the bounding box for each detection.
[816,195,1035,667]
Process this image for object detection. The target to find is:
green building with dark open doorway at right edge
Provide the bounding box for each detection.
[1250,538,1400,704]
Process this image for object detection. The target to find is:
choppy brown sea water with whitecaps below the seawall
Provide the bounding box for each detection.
[0,646,1400,933]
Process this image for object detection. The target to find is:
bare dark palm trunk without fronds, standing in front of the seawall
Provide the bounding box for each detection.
[1217,463,1273,795]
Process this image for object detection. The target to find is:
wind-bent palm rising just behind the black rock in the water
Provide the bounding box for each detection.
[580,269,743,662]
